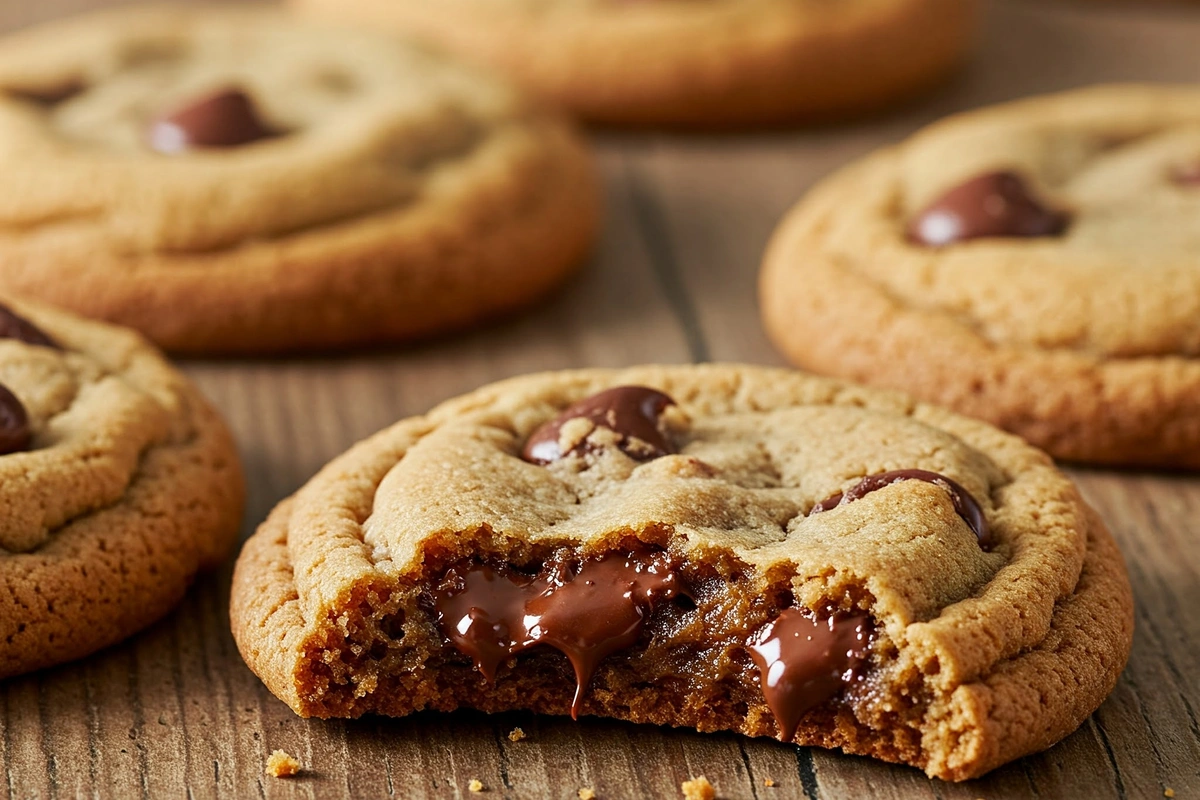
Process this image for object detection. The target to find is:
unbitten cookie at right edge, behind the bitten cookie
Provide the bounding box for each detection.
[761,85,1200,469]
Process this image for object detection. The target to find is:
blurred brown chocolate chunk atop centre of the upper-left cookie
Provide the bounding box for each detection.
[148,89,277,154]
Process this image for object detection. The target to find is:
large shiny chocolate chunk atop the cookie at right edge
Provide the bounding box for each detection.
[908,172,1069,247]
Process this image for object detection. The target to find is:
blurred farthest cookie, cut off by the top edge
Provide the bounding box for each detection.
[292,0,977,126]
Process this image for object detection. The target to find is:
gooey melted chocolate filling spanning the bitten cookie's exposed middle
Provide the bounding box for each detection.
[427,548,875,740]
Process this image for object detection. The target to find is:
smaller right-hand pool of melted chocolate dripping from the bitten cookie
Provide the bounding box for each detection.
[748,608,872,741]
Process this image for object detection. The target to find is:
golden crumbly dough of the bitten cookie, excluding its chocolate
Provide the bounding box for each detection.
[230,365,1133,780]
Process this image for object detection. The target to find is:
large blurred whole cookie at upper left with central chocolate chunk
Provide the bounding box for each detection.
[0,7,599,354]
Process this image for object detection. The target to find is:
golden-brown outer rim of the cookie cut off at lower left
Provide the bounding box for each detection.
[0,301,245,676]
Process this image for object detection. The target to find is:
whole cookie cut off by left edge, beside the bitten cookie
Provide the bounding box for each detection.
[0,300,244,678]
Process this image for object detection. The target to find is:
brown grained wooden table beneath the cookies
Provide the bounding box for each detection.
[0,0,1200,800]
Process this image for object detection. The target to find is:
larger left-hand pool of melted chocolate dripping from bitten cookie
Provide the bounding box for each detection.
[431,553,686,717]
